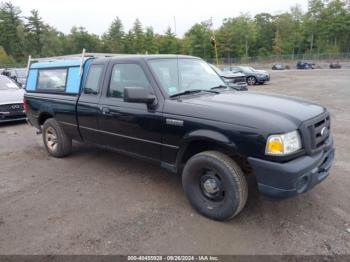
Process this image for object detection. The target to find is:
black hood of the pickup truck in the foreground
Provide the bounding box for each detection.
[167,92,326,133]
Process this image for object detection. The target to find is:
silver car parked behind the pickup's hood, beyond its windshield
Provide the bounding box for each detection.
[223,66,270,85]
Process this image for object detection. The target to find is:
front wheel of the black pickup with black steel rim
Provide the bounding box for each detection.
[182,151,248,221]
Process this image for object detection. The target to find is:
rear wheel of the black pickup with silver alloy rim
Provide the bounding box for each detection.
[42,118,72,157]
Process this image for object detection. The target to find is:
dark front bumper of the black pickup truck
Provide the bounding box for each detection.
[248,137,335,198]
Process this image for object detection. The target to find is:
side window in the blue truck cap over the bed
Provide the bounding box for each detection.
[37,68,67,92]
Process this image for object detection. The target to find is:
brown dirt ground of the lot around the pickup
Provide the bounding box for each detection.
[0,70,350,255]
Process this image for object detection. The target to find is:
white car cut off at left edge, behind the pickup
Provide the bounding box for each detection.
[0,75,26,123]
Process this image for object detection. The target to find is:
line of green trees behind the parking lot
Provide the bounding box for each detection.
[0,0,350,64]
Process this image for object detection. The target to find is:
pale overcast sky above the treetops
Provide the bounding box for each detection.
[9,0,307,37]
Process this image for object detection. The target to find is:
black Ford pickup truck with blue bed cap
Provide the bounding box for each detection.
[24,55,334,220]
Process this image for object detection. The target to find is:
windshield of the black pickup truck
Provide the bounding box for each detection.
[149,58,226,96]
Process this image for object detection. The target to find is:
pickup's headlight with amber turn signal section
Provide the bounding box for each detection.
[265,130,301,156]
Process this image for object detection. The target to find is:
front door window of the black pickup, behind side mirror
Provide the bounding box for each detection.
[108,64,151,98]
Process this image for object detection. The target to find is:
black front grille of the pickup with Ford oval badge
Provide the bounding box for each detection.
[309,114,331,151]
